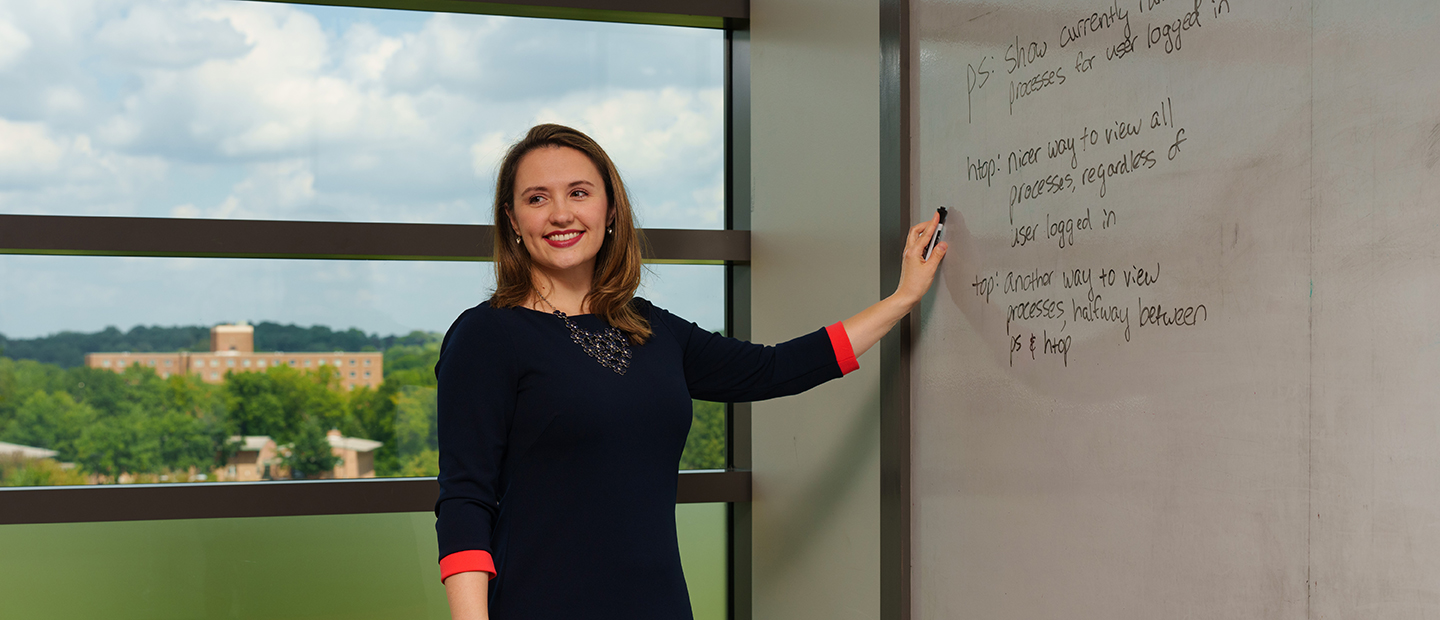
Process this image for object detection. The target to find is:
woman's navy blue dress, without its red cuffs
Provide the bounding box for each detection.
[435,298,850,620]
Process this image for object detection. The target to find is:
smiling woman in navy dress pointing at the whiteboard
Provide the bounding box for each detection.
[435,125,946,620]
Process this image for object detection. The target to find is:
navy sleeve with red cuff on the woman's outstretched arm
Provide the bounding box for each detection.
[651,306,860,403]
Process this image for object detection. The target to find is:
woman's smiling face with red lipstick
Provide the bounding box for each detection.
[510,147,609,275]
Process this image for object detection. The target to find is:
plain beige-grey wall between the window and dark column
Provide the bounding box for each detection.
[750,0,880,620]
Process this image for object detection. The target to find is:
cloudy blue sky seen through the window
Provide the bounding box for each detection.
[0,0,723,338]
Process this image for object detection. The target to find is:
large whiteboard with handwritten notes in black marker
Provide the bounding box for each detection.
[910,0,1440,620]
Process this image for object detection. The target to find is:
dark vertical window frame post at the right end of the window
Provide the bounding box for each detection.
[724,26,752,620]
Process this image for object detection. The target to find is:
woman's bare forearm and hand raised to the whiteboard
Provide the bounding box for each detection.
[844,213,959,357]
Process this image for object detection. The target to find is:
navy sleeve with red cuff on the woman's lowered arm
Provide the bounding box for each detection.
[435,306,517,581]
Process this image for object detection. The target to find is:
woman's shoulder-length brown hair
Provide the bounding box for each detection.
[490,125,649,345]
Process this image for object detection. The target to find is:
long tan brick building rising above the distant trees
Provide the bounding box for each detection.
[85,324,384,390]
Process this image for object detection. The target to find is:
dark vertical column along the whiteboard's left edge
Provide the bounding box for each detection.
[878,0,914,620]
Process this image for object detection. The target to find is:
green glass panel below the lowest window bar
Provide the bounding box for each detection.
[0,503,726,620]
